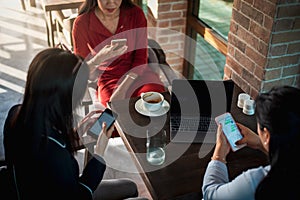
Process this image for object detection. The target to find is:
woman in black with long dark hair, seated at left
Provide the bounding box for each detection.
[4,48,148,200]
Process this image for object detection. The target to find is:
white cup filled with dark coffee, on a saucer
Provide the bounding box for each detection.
[141,92,164,111]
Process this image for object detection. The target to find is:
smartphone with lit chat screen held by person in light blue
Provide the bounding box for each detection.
[215,112,246,151]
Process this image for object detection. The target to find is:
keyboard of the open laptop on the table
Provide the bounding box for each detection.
[171,117,218,132]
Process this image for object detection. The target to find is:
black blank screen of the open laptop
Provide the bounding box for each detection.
[170,79,234,117]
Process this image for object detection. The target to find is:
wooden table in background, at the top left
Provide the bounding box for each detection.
[41,0,84,47]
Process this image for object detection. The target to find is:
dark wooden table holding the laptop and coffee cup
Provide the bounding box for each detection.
[110,83,268,200]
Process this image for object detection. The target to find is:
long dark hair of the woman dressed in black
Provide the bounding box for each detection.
[13,48,89,153]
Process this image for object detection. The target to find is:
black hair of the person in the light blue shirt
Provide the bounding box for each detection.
[255,86,300,199]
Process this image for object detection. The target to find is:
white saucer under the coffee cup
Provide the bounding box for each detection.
[135,99,170,117]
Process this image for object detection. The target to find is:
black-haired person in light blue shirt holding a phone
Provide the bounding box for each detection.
[202,86,300,200]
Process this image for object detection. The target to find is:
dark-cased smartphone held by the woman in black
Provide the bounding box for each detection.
[87,108,117,139]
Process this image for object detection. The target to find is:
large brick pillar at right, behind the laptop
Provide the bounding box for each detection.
[224,0,300,97]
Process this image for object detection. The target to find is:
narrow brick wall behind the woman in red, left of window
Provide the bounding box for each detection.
[147,0,187,73]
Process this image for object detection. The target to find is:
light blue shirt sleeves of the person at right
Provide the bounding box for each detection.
[202,160,270,200]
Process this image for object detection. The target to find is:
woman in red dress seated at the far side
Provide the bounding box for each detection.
[72,0,165,107]
